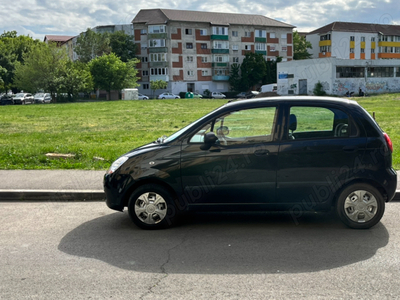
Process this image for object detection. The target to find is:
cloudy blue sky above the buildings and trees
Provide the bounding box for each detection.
[0,0,400,40]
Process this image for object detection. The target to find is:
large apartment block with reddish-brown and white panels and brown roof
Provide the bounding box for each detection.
[132,9,294,94]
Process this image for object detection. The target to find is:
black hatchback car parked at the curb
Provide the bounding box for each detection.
[104,96,397,229]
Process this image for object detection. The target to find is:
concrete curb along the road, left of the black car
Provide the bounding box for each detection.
[0,190,106,202]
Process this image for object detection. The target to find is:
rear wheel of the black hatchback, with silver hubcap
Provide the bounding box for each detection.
[336,183,385,229]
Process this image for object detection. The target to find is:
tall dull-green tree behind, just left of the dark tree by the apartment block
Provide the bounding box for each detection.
[74,28,111,63]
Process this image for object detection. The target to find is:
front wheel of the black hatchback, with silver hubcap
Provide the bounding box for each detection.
[128,184,178,229]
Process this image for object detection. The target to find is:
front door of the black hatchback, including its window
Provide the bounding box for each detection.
[181,106,279,206]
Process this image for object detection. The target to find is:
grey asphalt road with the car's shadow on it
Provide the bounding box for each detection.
[0,202,400,299]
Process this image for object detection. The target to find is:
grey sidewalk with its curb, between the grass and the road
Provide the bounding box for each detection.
[0,170,400,201]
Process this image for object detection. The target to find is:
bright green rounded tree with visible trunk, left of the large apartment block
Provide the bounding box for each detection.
[89,53,139,99]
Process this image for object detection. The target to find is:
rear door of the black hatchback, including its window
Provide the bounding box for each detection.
[277,105,366,210]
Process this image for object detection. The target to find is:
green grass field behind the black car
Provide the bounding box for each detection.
[0,94,400,170]
